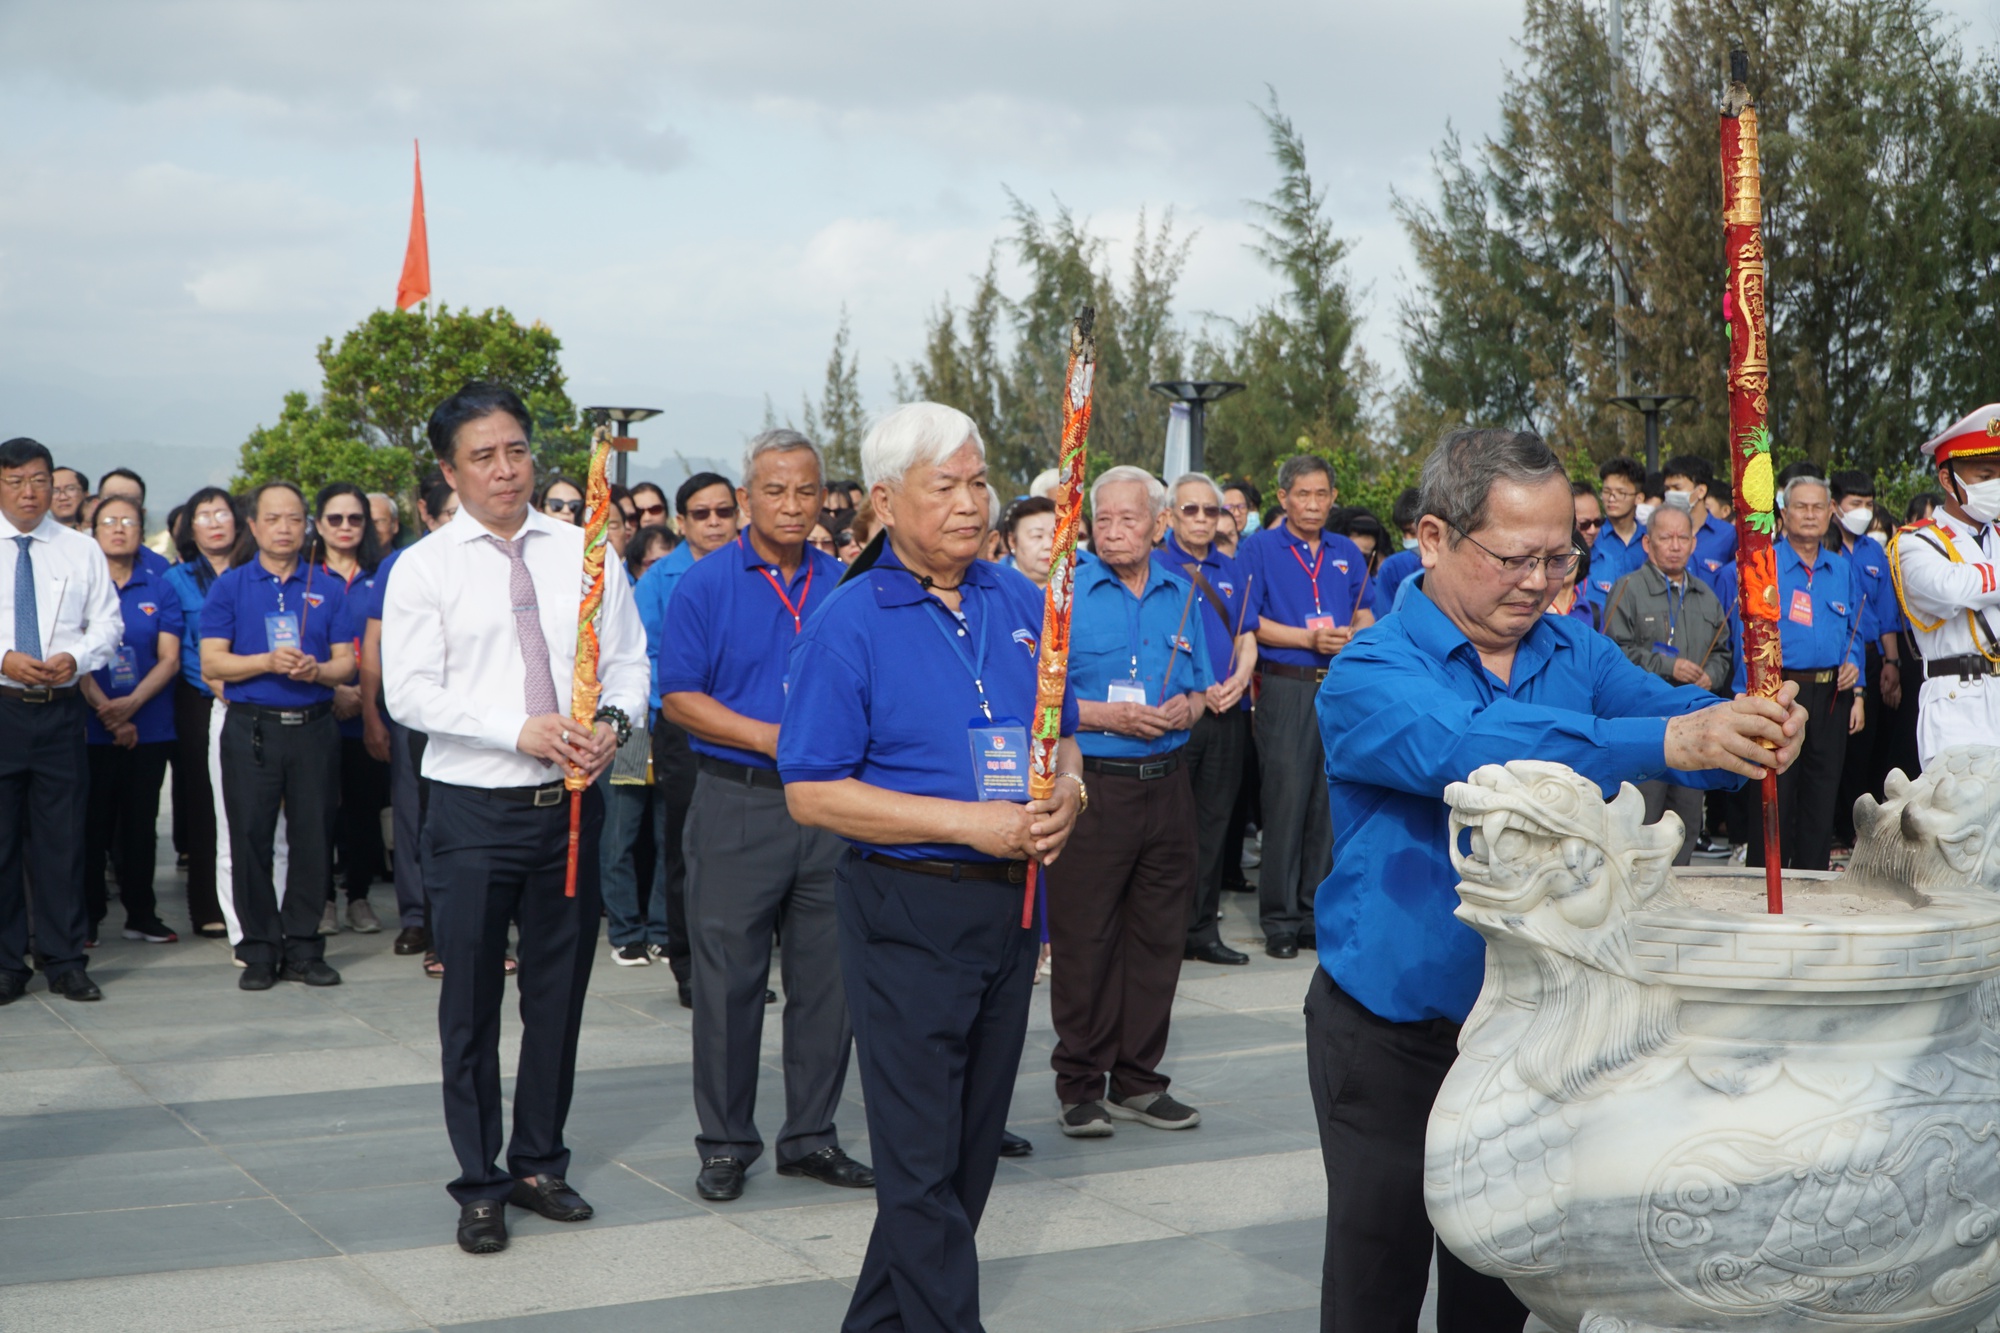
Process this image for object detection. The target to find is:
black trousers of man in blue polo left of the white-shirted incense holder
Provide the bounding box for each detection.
[222,705,340,963]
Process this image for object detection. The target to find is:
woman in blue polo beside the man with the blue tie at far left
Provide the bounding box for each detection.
[78,494,184,945]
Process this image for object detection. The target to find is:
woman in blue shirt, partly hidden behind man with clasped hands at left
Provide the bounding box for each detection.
[166,486,236,939]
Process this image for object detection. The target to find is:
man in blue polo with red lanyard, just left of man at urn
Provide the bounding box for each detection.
[1236,454,1374,959]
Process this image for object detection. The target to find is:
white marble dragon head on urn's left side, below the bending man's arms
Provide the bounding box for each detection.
[1444,759,1682,977]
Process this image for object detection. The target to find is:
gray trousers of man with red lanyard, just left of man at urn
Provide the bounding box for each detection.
[1256,671,1334,939]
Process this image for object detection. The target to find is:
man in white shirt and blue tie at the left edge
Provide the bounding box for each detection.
[0,438,124,1005]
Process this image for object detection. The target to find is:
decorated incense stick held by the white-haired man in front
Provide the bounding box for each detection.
[1020,306,1098,931]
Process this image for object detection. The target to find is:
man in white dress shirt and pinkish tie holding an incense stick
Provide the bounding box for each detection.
[382,384,648,1255]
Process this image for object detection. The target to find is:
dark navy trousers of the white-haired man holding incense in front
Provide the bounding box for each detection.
[836,851,1040,1333]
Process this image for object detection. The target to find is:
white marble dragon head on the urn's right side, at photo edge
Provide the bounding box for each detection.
[1848,745,2000,893]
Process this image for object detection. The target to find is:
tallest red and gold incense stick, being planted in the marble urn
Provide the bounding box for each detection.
[1722,46,1784,913]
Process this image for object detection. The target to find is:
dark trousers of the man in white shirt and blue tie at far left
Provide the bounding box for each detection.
[0,695,90,977]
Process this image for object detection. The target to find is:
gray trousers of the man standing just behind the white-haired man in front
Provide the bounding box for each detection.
[682,771,854,1163]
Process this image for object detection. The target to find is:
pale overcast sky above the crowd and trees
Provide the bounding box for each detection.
[0,0,1996,492]
